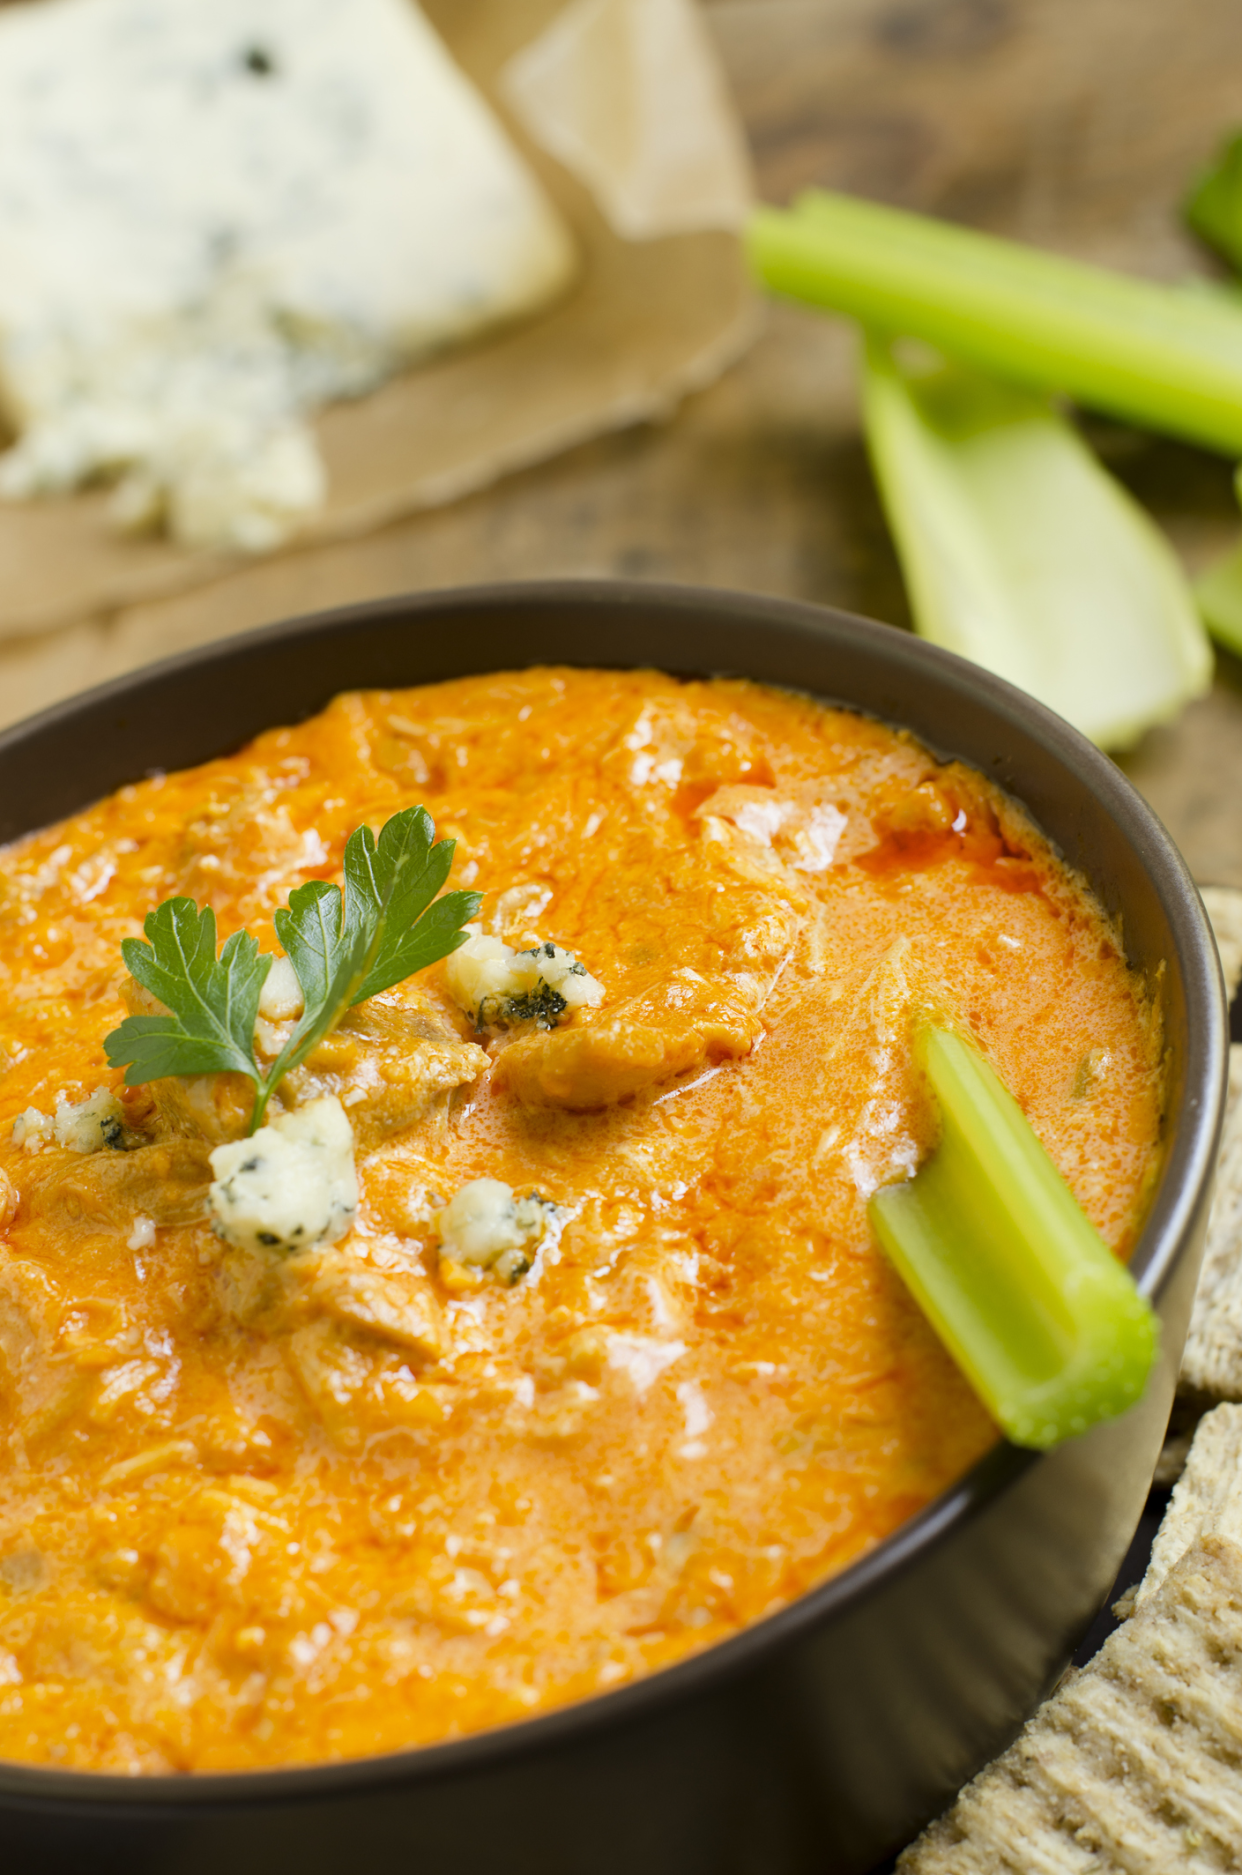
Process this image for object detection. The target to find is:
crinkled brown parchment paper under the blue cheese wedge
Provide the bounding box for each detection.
[0,0,756,645]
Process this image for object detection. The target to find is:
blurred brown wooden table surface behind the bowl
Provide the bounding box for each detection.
[17,0,1242,885]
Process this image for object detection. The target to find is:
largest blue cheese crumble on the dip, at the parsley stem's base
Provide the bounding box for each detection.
[208,1095,358,1253]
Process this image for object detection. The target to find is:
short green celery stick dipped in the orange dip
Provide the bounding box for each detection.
[871,1024,1159,1451]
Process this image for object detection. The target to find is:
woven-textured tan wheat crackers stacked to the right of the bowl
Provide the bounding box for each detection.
[897,887,1242,1875]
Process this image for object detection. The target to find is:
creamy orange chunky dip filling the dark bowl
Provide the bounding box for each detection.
[0,669,1159,1772]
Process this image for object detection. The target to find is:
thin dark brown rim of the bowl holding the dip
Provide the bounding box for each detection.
[0,579,1229,1817]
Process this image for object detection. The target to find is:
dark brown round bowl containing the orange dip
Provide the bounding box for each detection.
[0,583,1227,1875]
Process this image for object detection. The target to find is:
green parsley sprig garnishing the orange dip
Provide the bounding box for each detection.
[103,808,480,1133]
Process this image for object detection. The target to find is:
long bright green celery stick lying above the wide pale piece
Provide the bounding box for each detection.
[747,191,1242,456]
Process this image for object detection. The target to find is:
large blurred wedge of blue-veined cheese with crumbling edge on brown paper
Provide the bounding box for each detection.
[0,0,574,551]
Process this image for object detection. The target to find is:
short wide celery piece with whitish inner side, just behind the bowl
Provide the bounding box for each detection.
[863,336,1212,748]
